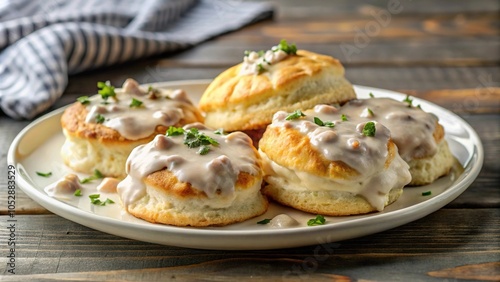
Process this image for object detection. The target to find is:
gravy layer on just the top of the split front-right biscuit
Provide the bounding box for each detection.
[270,105,391,176]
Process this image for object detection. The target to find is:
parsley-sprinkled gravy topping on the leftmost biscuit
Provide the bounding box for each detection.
[85,79,197,140]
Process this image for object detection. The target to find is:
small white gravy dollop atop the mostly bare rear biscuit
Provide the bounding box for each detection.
[239,50,288,75]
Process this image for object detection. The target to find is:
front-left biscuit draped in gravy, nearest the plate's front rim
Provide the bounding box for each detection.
[118,124,268,226]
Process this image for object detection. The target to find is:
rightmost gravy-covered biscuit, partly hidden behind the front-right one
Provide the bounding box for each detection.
[340,97,454,185]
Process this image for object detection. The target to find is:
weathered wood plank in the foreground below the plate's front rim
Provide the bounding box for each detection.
[0,209,500,281]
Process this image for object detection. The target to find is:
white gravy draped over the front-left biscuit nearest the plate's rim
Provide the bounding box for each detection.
[117,123,261,206]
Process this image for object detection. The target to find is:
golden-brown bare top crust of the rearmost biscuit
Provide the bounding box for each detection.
[199,50,344,112]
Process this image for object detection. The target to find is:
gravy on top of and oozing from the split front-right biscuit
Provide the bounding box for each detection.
[264,105,411,210]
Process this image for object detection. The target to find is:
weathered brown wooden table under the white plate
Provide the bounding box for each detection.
[0,0,500,281]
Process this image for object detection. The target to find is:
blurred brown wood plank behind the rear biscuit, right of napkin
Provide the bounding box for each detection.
[161,9,500,67]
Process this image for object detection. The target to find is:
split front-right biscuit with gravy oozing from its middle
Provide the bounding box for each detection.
[259,105,411,216]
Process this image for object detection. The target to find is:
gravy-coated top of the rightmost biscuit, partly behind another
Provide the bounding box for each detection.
[339,97,444,162]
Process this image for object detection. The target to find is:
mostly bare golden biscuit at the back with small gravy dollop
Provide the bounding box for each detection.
[199,45,356,137]
